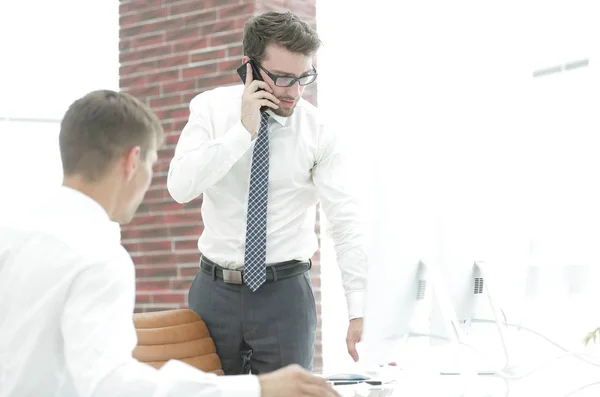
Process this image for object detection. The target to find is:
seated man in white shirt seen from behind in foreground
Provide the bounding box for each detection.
[0,91,336,397]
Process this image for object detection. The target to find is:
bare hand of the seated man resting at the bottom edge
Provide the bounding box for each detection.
[258,365,339,397]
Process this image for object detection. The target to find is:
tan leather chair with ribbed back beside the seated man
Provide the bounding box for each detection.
[133,309,223,375]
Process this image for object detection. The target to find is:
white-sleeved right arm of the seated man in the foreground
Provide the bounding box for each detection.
[61,252,261,397]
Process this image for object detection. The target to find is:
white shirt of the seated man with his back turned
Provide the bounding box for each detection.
[0,187,260,397]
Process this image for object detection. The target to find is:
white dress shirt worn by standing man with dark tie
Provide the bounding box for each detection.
[167,85,367,318]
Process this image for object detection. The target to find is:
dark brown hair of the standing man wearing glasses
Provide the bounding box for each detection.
[243,11,321,62]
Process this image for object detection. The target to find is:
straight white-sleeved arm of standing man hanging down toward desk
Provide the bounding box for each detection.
[312,125,368,320]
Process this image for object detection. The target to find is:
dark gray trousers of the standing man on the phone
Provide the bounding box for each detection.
[188,264,317,375]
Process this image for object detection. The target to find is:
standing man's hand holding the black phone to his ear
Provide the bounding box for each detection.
[242,62,279,138]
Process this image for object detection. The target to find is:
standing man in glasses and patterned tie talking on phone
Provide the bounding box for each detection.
[167,12,367,374]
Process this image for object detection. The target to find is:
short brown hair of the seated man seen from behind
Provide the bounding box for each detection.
[59,90,164,181]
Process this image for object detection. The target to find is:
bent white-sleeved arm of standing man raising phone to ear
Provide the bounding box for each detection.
[167,94,251,203]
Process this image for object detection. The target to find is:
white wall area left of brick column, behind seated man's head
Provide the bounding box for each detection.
[0,0,119,219]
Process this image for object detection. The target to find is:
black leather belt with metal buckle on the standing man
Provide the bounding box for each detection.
[200,256,312,284]
